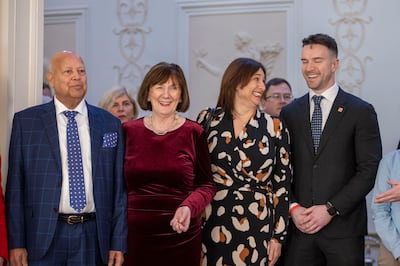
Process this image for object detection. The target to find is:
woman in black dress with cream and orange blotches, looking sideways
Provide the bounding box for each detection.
[197,58,292,266]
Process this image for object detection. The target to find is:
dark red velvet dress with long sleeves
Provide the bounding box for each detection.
[124,118,215,266]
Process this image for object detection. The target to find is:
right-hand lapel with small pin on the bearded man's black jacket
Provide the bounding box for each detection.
[318,88,347,154]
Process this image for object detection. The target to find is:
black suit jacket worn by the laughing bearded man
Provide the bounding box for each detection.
[281,89,382,238]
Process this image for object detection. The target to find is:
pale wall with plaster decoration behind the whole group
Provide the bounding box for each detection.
[0,0,400,237]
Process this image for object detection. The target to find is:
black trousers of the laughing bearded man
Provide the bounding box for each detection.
[285,230,364,266]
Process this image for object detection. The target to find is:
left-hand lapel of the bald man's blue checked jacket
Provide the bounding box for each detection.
[40,101,61,169]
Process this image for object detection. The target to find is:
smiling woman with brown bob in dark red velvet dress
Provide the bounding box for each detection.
[123,62,215,266]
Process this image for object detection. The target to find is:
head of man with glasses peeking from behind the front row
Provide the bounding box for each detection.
[260,78,293,116]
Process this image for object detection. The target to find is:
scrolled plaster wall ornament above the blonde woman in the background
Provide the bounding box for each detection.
[113,0,151,94]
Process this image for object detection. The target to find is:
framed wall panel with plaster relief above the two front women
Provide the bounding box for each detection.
[176,0,296,118]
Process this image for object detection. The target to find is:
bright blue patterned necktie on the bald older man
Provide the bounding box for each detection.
[64,111,86,212]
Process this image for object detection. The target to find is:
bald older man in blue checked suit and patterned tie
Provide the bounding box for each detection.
[6,51,127,266]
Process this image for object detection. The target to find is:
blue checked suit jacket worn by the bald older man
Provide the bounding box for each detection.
[6,101,127,263]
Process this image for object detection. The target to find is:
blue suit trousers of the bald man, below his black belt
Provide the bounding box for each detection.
[28,219,104,266]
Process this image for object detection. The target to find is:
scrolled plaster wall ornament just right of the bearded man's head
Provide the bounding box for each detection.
[331,0,372,95]
